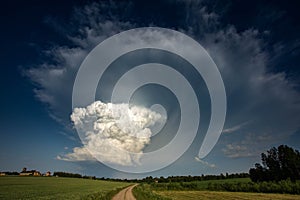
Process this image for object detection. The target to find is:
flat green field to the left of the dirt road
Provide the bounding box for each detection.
[0,176,130,200]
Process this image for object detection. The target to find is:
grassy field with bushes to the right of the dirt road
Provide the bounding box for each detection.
[134,178,300,200]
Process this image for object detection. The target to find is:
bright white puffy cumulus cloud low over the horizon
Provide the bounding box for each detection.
[58,101,165,166]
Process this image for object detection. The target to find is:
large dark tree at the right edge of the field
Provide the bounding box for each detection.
[249,145,300,182]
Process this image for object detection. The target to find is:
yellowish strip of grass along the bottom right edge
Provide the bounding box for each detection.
[155,191,300,200]
